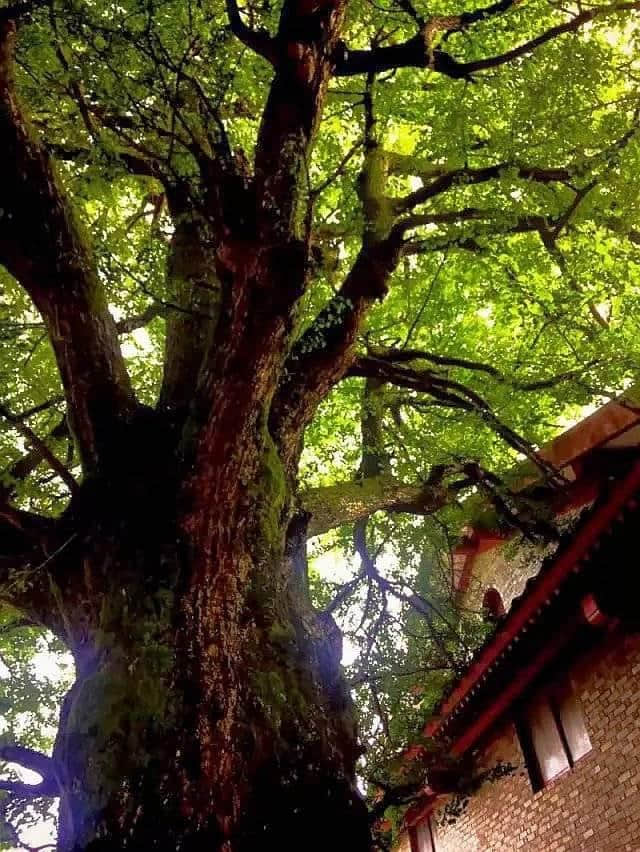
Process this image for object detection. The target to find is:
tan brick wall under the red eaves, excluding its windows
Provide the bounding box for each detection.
[416,636,640,852]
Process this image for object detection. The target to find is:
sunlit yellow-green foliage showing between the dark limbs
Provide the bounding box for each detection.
[0,0,640,844]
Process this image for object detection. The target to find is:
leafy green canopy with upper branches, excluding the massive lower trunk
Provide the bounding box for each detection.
[0,0,640,848]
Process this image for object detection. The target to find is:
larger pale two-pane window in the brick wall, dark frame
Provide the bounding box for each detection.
[517,682,591,791]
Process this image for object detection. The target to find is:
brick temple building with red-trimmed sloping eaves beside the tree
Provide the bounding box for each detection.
[396,399,640,852]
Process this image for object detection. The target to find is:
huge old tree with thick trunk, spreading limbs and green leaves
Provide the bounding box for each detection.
[0,0,640,852]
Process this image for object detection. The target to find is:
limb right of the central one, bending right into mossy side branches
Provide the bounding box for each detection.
[270,115,624,466]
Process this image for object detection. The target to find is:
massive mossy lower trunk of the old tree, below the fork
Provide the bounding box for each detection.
[54,431,369,852]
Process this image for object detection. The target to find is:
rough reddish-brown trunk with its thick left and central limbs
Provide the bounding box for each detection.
[0,0,376,852]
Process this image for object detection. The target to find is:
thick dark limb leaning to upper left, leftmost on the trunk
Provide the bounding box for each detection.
[0,24,136,470]
